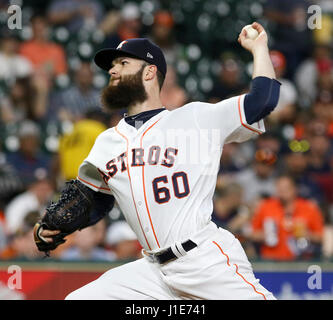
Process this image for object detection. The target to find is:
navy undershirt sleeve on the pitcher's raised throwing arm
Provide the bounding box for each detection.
[244,77,281,124]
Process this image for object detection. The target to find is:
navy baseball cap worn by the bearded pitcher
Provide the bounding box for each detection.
[94,38,167,77]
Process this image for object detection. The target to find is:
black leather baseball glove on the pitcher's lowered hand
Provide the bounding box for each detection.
[33,180,95,255]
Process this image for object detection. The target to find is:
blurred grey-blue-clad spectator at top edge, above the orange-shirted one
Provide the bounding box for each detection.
[47,0,103,33]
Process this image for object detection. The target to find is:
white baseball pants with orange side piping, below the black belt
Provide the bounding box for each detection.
[66,222,275,300]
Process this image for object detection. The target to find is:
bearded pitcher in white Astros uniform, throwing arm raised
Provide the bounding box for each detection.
[34,22,280,300]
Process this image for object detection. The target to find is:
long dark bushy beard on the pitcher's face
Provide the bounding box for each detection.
[101,67,148,111]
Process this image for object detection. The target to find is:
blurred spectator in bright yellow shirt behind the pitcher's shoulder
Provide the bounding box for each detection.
[57,110,107,181]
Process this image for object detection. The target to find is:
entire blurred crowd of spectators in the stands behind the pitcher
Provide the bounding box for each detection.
[0,0,333,261]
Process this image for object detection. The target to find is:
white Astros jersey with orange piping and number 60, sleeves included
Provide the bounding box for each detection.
[78,95,265,252]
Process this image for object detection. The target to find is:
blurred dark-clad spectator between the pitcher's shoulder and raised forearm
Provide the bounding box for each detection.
[208,55,247,103]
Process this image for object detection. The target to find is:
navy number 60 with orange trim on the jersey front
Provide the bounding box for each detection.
[153,171,190,204]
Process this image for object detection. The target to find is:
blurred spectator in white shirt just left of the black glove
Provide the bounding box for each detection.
[5,179,54,235]
